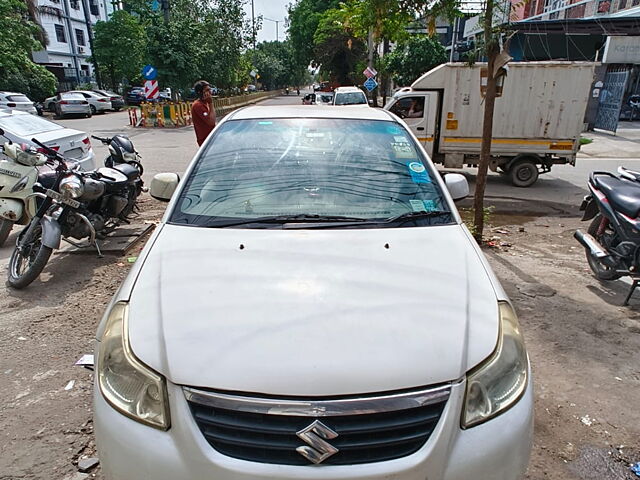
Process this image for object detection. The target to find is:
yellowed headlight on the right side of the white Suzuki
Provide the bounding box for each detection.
[462,302,529,428]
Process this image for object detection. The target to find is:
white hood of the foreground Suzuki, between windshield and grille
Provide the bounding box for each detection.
[129,225,498,396]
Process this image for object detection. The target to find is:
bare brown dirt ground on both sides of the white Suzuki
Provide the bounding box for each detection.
[0,199,640,480]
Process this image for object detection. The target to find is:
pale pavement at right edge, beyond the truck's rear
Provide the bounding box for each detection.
[578,122,640,158]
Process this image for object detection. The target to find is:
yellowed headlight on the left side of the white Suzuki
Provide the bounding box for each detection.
[96,302,170,430]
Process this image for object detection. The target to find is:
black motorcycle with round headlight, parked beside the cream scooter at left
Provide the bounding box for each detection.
[7,138,142,289]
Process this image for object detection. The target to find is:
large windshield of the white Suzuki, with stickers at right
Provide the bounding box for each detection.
[170,118,452,228]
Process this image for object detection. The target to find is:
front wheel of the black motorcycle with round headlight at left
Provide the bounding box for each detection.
[7,224,53,289]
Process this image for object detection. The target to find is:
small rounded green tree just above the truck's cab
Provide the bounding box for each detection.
[384,35,447,86]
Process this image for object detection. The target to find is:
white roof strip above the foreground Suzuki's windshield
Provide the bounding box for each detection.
[229,105,398,122]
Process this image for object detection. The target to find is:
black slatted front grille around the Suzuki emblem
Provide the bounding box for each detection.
[185,388,449,465]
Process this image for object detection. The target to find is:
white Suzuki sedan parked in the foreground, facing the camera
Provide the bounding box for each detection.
[94,105,533,480]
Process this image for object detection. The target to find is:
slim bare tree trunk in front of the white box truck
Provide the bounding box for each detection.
[473,0,500,243]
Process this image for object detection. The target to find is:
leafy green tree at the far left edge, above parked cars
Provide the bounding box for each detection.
[0,0,57,100]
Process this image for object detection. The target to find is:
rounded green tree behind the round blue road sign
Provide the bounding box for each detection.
[93,10,147,90]
